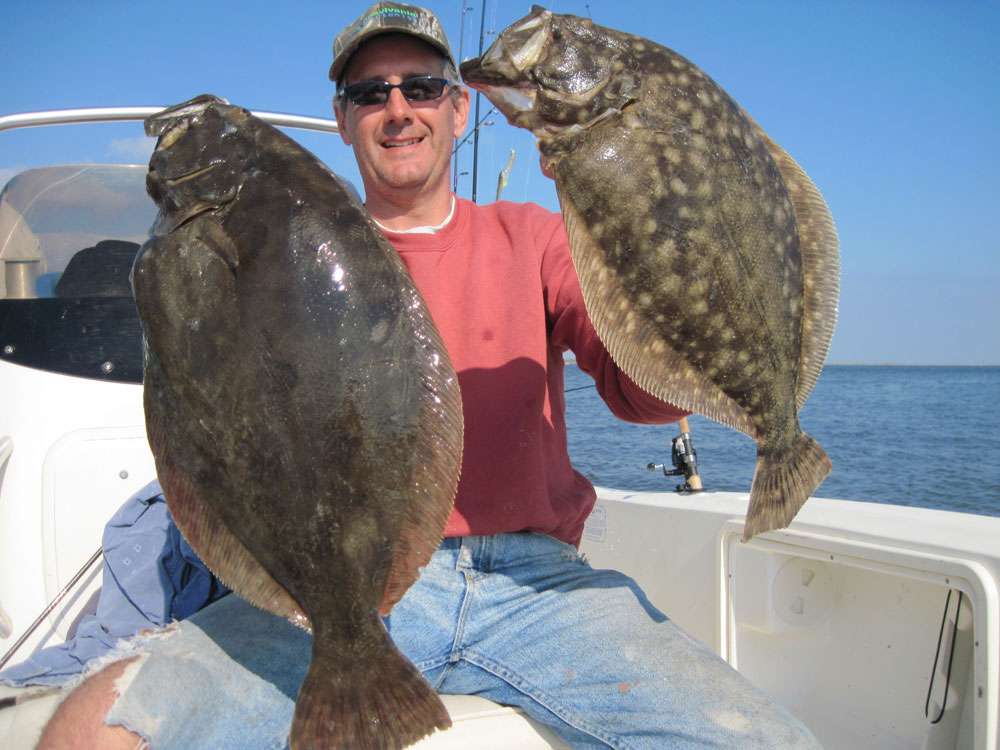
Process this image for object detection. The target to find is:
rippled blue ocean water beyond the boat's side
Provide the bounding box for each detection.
[566,364,1000,516]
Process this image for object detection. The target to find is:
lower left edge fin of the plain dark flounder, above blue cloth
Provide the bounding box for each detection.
[145,390,310,630]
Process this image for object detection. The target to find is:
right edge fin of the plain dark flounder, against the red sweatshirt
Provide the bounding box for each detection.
[379,287,464,615]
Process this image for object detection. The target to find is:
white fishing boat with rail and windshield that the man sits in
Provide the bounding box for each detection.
[0,107,1000,750]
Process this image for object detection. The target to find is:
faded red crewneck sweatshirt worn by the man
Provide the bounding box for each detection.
[386,199,687,545]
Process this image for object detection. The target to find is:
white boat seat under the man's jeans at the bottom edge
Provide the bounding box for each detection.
[0,685,569,750]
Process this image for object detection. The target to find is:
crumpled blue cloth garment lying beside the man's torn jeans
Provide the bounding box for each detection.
[0,481,229,686]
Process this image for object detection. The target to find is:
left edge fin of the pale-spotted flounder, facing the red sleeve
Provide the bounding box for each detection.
[556,192,756,437]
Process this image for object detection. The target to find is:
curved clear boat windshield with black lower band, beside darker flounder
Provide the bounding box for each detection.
[0,164,156,382]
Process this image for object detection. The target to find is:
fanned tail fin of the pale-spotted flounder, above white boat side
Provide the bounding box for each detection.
[743,431,832,542]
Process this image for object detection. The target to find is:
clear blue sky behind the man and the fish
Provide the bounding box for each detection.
[0,0,1000,364]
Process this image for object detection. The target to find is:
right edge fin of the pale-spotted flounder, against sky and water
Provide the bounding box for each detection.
[748,122,840,410]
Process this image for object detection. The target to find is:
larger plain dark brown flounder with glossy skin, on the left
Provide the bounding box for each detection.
[132,96,462,750]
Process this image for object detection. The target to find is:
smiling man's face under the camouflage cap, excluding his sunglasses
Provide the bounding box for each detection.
[336,34,469,203]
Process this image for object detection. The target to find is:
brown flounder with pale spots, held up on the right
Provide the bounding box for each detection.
[462,7,839,538]
